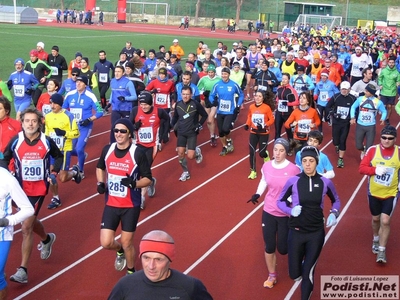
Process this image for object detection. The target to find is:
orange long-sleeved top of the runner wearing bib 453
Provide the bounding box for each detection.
[246,103,275,134]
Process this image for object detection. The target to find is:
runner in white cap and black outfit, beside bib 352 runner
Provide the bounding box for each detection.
[326,81,355,168]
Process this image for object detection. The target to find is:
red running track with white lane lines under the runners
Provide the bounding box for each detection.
[6,20,400,300]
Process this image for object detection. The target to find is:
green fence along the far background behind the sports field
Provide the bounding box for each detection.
[1,0,400,30]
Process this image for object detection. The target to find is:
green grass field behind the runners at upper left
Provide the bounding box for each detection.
[0,24,234,80]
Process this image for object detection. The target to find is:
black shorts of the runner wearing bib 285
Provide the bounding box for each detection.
[101,205,140,232]
